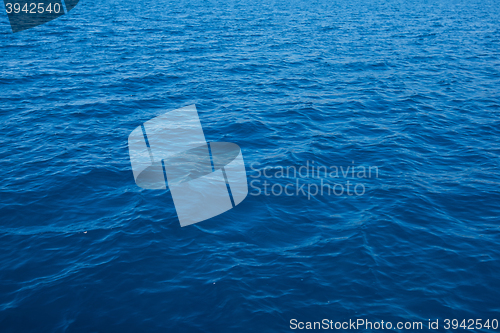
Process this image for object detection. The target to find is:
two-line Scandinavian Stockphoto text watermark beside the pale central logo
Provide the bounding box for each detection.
[250,160,379,200]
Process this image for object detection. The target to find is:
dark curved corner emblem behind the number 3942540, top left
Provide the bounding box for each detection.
[3,0,80,33]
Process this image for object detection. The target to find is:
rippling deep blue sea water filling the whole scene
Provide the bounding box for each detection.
[0,0,500,332]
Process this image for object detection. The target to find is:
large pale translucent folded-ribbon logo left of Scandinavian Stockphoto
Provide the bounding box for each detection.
[128,105,248,227]
